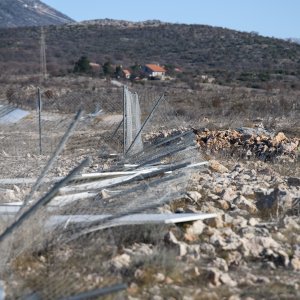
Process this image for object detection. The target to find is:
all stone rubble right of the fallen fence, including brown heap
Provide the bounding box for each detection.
[1,122,300,300]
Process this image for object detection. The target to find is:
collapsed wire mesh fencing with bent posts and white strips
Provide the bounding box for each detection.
[0,82,206,299]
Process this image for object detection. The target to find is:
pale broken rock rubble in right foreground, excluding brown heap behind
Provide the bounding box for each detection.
[104,155,300,300]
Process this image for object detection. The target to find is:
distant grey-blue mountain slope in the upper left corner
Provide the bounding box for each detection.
[0,0,73,28]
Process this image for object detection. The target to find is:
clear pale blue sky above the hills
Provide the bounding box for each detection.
[42,0,300,38]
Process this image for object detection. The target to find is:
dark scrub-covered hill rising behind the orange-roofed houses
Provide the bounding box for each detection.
[0,20,300,88]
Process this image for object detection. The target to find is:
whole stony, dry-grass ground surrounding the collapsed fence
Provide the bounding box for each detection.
[0,77,300,300]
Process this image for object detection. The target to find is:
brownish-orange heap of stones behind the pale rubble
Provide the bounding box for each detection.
[194,128,300,161]
